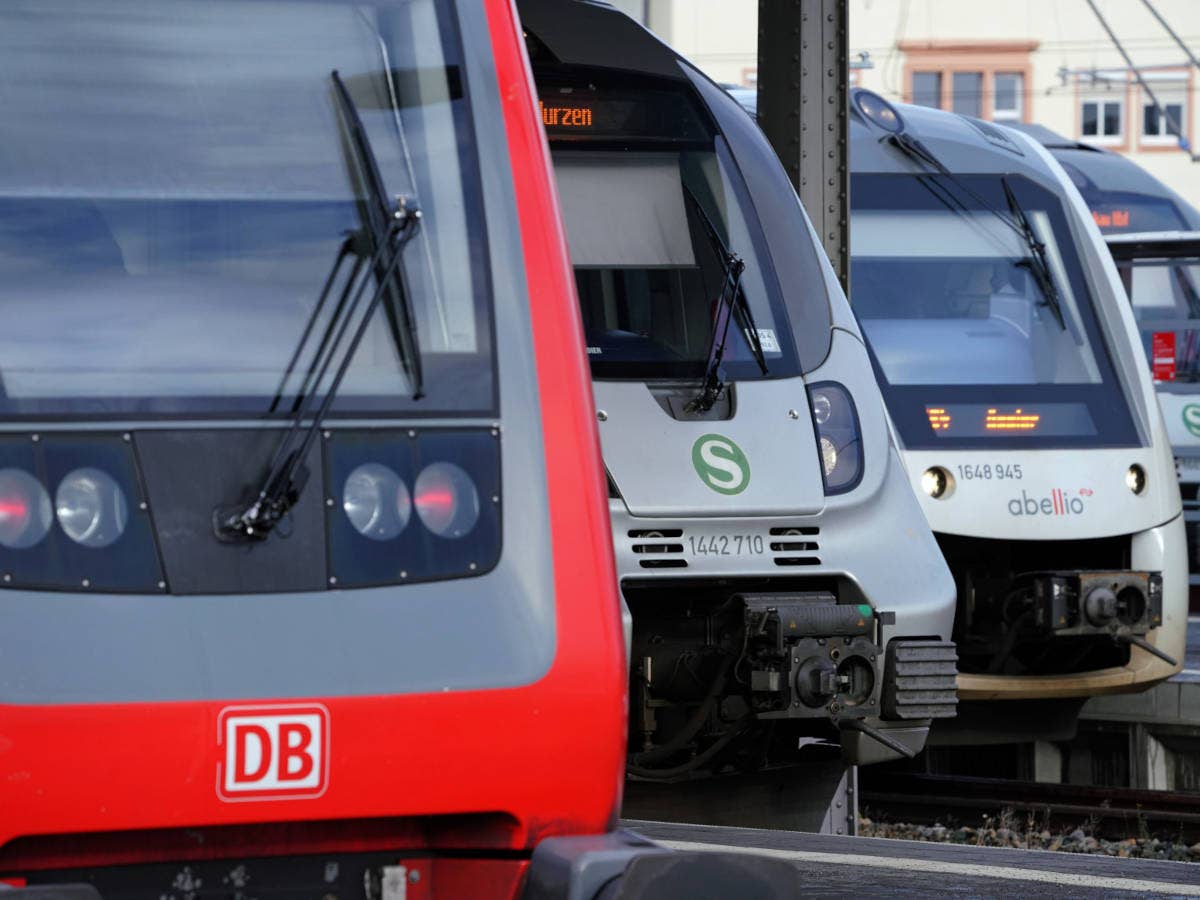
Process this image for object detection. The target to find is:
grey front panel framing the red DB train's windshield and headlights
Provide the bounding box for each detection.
[0,0,556,704]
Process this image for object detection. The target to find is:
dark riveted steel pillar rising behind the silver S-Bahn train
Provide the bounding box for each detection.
[758,0,850,293]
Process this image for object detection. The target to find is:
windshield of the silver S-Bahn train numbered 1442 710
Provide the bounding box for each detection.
[538,74,798,380]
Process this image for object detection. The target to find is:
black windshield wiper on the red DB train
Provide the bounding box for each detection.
[212,71,422,541]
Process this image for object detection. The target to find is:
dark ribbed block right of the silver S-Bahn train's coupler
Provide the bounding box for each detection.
[883,641,959,719]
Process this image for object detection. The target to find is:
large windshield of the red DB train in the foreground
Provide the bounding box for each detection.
[0,0,496,418]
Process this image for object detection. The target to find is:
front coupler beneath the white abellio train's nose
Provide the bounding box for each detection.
[1019,570,1177,666]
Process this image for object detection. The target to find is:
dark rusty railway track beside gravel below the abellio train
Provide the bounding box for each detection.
[859,769,1200,842]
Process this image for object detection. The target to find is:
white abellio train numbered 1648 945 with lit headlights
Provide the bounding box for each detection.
[851,91,1187,701]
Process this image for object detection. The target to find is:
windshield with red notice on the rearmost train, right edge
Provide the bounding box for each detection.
[1110,238,1200,391]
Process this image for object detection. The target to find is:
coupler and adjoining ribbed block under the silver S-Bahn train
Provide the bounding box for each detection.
[739,592,958,757]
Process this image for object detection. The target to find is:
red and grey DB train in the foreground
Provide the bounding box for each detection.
[0,0,662,898]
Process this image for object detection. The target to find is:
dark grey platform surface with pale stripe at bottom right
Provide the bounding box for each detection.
[623,821,1200,898]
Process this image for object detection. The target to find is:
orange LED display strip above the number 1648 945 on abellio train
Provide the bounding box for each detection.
[925,403,1096,438]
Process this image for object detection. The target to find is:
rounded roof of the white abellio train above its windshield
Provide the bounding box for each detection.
[850,88,1057,184]
